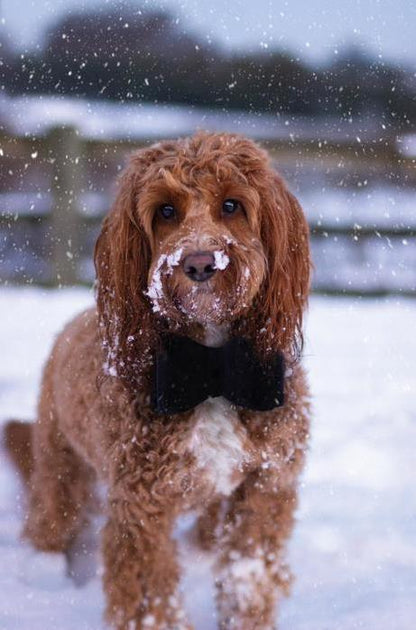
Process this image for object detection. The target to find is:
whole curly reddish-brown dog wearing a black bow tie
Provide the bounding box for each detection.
[7,132,311,630]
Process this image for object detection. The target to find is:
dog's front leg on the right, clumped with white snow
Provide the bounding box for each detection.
[216,471,296,630]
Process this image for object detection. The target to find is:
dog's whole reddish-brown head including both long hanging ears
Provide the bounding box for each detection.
[95,133,310,388]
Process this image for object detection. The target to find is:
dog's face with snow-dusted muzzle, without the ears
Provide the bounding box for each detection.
[137,142,267,325]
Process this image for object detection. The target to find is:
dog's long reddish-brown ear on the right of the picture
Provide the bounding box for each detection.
[249,171,311,359]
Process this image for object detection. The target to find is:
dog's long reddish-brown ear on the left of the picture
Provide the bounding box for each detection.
[94,149,154,385]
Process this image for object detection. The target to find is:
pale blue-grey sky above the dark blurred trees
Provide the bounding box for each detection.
[0,0,416,69]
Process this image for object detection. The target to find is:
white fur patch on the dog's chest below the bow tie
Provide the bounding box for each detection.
[187,397,249,496]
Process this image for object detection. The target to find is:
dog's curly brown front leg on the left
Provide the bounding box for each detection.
[103,496,192,630]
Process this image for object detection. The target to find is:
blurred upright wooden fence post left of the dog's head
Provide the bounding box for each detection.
[48,127,82,285]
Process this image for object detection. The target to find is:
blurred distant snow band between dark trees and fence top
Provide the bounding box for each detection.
[0,93,413,147]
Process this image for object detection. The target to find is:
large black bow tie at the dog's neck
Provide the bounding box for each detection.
[152,335,284,414]
